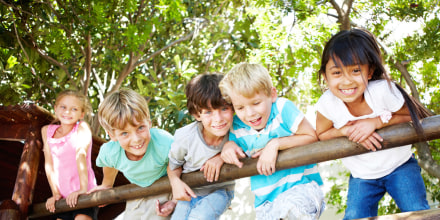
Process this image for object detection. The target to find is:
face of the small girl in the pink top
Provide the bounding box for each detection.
[54,95,84,124]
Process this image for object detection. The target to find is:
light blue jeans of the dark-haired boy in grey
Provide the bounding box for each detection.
[171,189,234,220]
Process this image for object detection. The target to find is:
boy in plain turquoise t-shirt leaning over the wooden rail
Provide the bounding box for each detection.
[92,89,176,219]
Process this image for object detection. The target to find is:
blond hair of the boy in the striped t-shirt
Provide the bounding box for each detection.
[219,62,273,103]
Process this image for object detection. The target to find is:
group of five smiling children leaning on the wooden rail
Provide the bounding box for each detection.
[42,29,429,219]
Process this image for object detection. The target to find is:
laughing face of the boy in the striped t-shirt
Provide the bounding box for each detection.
[228,88,277,131]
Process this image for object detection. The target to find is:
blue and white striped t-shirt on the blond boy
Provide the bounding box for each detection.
[229,98,322,207]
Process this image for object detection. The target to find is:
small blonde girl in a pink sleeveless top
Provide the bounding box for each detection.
[41,90,98,220]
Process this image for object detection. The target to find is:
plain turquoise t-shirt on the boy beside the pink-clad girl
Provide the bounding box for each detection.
[96,128,173,187]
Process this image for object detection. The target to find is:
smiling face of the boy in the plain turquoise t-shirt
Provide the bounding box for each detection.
[109,119,151,161]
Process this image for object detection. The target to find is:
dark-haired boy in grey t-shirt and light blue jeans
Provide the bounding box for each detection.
[168,74,234,220]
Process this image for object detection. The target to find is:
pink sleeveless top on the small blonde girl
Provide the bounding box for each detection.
[47,124,96,197]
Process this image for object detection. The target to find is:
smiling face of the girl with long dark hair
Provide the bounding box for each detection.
[324,56,372,104]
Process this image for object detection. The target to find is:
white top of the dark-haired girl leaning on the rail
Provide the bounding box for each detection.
[316,80,412,179]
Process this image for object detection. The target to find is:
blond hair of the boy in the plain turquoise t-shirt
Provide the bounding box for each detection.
[98,89,150,134]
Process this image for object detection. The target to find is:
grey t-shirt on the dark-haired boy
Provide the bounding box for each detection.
[168,122,235,196]
